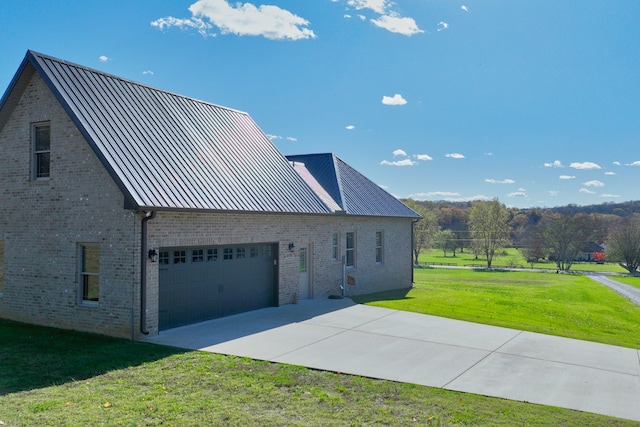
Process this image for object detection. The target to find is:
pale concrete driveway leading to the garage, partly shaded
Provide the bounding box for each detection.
[148,299,640,421]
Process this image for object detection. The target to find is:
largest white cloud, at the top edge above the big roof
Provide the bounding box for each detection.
[151,0,316,40]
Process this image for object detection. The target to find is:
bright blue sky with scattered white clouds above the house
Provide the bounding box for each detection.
[0,0,640,207]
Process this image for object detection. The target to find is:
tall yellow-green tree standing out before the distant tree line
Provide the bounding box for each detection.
[469,199,511,268]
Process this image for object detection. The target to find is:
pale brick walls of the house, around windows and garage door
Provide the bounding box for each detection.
[0,75,411,338]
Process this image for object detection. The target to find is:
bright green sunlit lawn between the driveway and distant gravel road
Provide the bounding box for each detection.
[354,268,640,349]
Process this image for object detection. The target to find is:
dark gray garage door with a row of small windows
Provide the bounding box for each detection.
[158,243,277,330]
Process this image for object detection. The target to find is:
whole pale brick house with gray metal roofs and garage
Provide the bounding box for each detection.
[0,51,419,339]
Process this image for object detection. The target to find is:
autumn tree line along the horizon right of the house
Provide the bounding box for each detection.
[403,199,640,274]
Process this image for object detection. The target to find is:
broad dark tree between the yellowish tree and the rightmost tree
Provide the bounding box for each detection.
[544,214,598,271]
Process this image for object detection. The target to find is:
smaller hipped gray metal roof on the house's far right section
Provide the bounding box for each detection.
[287,153,420,218]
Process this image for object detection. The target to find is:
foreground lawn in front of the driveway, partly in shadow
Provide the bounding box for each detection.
[0,320,638,427]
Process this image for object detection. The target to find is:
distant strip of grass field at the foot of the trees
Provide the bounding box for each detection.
[418,248,627,273]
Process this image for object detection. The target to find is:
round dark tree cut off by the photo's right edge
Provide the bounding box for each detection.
[606,214,640,274]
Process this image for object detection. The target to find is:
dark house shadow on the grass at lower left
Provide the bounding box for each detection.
[0,319,185,395]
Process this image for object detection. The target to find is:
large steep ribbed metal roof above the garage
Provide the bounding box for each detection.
[0,51,331,214]
